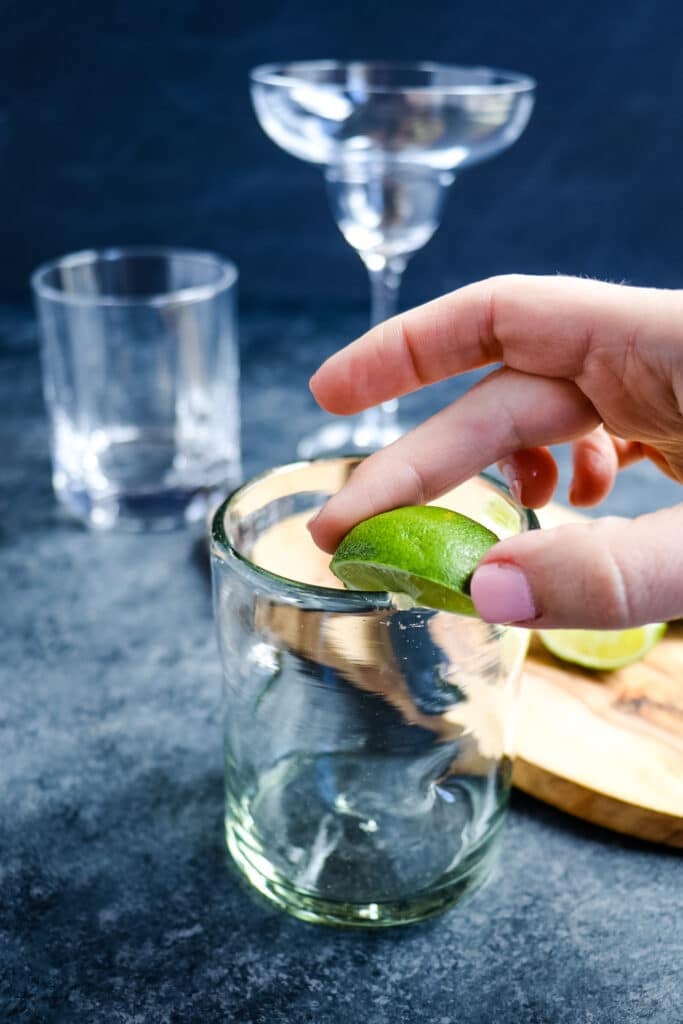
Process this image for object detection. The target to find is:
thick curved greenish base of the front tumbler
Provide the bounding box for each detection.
[225,809,506,928]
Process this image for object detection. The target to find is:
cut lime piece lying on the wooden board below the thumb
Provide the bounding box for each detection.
[539,623,667,672]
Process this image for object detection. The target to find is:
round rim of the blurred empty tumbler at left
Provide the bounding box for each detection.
[30,246,240,307]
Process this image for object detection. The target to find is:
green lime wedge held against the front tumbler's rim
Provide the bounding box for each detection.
[330,505,498,615]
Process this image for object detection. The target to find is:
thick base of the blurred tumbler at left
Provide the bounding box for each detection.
[54,480,237,532]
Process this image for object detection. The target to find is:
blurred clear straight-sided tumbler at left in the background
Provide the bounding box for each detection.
[31,248,241,528]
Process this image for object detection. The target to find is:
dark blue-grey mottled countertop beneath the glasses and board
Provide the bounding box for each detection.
[0,309,683,1024]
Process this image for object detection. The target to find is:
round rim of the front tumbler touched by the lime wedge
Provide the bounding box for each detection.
[211,455,540,614]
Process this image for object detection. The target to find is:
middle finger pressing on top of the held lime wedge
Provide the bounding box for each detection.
[309,369,598,552]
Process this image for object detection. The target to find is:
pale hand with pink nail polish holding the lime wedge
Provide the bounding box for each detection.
[309,275,683,629]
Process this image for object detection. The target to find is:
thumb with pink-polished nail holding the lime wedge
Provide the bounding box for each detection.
[470,505,683,630]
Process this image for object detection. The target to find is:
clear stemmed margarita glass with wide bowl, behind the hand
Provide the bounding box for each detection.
[251,60,536,458]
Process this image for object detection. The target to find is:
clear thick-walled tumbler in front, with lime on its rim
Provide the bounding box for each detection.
[211,458,538,926]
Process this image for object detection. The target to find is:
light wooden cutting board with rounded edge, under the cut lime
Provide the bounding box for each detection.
[513,507,683,849]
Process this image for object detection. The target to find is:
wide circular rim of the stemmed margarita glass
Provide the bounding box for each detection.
[249,59,537,96]
